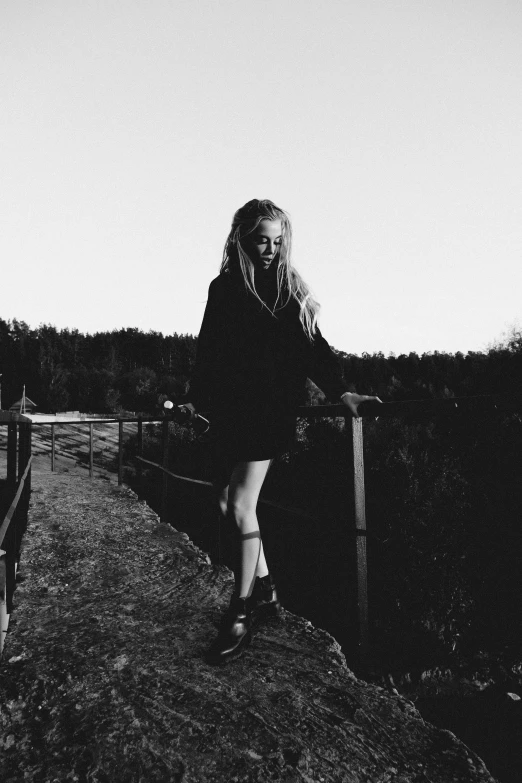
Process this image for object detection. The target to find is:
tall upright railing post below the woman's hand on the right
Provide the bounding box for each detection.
[350,417,368,660]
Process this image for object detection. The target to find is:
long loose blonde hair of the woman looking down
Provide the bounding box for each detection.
[220,199,319,340]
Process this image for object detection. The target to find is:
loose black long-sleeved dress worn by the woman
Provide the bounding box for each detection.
[187,272,347,474]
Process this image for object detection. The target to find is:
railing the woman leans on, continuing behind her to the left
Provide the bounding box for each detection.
[2,395,522,657]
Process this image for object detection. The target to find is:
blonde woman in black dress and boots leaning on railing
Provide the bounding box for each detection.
[184,199,378,663]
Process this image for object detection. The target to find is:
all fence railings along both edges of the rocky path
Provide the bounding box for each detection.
[0,395,522,658]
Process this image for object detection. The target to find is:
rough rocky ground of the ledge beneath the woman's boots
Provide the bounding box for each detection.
[0,460,493,783]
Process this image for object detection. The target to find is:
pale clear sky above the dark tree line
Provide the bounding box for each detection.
[0,0,522,354]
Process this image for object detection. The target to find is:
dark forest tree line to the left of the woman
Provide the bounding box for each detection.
[0,319,196,413]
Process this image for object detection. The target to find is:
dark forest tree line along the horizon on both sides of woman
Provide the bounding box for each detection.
[0,319,522,413]
